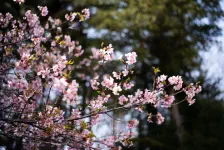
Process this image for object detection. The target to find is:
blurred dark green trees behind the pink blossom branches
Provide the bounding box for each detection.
[0,0,224,150]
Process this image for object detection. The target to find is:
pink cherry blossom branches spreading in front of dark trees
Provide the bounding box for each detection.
[0,0,201,149]
